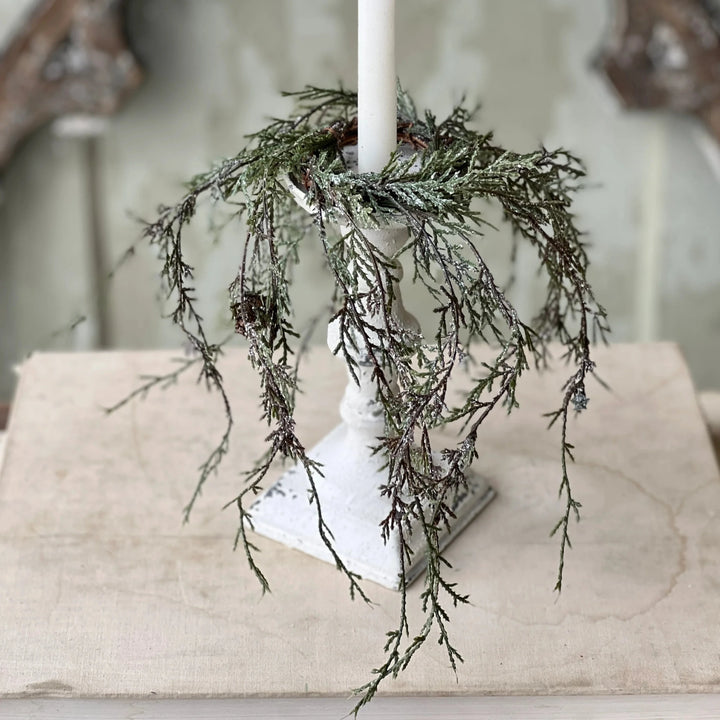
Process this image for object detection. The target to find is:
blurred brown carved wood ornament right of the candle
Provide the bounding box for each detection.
[600,0,720,141]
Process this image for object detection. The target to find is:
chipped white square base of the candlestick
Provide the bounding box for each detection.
[250,424,495,590]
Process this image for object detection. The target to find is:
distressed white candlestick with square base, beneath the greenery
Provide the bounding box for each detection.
[250,153,495,590]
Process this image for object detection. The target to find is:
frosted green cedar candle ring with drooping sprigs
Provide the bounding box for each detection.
[125,87,607,713]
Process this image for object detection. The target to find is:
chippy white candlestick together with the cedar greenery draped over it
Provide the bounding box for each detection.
[135,83,606,707]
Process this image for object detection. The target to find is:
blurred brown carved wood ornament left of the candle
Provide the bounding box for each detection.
[0,0,143,168]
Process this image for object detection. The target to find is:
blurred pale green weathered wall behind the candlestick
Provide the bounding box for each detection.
[0,0,720,403]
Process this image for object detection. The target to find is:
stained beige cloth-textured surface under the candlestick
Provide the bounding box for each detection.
[0,345,720,700]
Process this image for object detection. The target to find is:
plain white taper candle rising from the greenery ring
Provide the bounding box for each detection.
[358,0,397,173]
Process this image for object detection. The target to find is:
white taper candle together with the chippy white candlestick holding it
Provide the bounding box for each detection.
[251,0,495,590]
